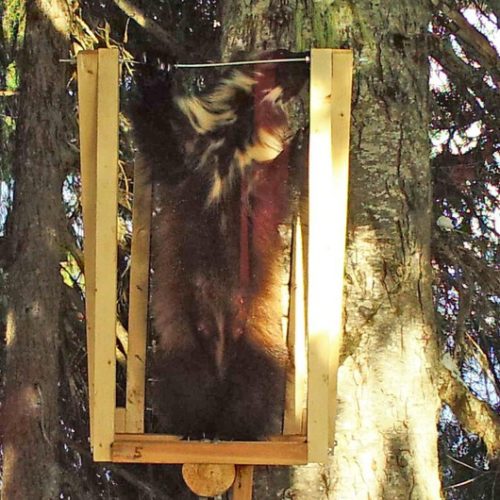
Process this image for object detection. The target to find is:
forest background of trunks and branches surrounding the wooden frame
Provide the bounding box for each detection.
[0,0,500,500]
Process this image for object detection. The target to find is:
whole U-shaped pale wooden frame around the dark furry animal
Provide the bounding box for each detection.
[77,49,352,488]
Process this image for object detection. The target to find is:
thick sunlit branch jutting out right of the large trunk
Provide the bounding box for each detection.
[439,356,500,456]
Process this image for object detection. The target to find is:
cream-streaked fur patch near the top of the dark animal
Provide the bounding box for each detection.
[175,68,288,207]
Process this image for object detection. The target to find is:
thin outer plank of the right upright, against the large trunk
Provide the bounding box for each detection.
[328,49,353,448]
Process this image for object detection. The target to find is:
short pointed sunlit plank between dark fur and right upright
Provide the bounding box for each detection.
[283,217,307,434]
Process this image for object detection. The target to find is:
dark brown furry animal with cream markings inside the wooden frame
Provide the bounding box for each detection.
[134,49,304,439]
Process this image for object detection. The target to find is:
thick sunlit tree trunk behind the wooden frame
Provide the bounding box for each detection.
[223,0,441,500]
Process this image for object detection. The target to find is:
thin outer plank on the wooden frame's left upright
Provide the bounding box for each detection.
[77,50,97,448]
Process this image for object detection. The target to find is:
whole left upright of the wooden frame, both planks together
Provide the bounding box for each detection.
[77,50,118,461]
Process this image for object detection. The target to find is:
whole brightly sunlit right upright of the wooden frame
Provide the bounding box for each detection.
[307,49,352,462]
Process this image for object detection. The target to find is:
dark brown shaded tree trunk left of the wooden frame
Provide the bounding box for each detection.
[2,0,71,500]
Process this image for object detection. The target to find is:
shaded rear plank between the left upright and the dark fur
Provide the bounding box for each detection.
[126,160,152,433]
